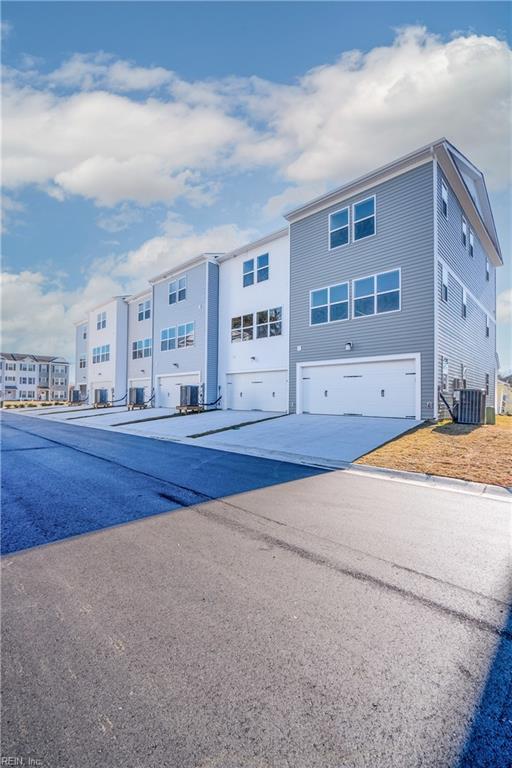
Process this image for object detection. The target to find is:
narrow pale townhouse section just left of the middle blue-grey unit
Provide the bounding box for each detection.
[127,288,153,404]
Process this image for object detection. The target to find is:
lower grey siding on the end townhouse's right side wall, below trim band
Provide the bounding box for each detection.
[437,264,496,416]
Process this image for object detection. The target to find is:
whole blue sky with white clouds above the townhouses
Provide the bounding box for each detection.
[1,2,512,371]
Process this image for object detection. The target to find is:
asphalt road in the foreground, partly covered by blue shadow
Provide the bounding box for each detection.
[2,415,512,768]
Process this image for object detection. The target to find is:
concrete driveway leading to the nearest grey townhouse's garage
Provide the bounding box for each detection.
[194,413,421,466]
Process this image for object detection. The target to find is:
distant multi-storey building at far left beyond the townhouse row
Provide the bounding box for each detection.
[0,352,69,401]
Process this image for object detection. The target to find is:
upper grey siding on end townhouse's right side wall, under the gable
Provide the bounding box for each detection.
[437,171,496,313]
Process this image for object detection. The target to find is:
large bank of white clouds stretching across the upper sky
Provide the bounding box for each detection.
[3,27,511,213]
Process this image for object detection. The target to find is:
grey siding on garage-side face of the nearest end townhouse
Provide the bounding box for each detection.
[290,162,434,418]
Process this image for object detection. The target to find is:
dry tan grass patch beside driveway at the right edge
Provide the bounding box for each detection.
[356,416,512,487]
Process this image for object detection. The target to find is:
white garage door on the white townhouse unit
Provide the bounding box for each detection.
[226,371,288,413]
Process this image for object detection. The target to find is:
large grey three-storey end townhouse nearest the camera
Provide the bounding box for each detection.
[287,140,502,419]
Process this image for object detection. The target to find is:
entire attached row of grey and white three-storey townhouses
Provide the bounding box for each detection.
[77,139,503,419]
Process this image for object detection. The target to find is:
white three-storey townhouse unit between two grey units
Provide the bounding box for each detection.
[217,228,290,411]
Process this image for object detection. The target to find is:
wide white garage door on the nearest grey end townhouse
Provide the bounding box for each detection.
[299,358,416,418]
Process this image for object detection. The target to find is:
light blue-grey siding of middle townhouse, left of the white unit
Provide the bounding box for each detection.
[153,262,216,397]
